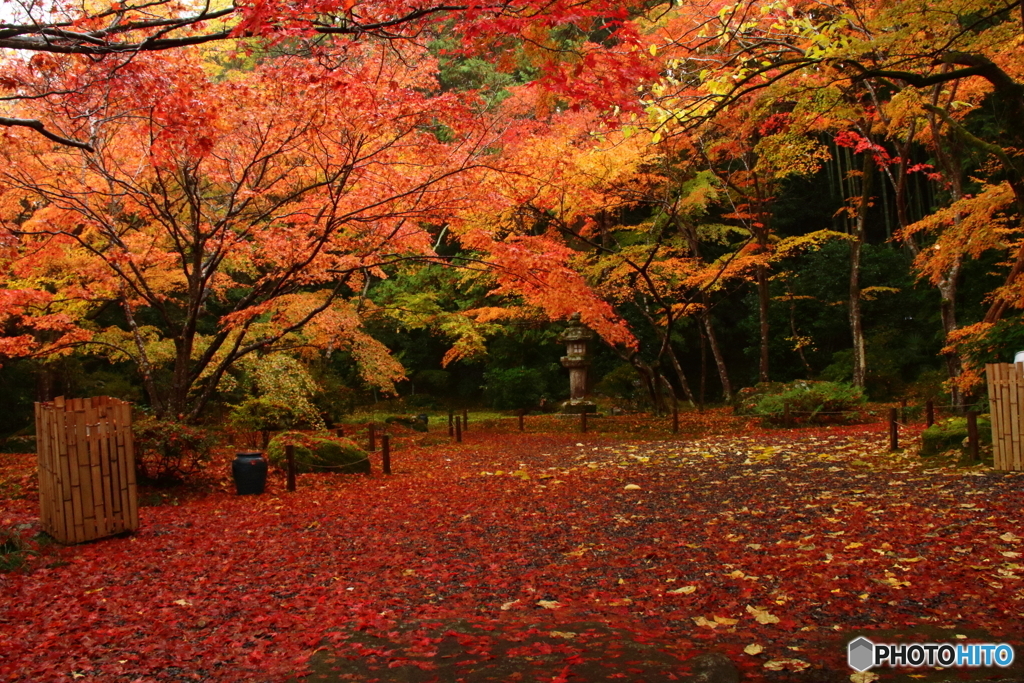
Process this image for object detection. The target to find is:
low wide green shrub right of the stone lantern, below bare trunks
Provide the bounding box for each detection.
[754,381,865,424]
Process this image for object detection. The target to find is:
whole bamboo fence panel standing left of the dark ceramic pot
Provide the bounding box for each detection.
[36,396,138,544]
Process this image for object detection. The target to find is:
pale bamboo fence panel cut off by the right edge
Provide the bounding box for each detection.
[985,362,1024,470]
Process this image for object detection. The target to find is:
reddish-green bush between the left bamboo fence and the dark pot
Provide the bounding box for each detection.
[132,417,215,485]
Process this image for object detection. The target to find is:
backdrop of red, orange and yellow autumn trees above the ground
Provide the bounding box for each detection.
[0,0,1024,444]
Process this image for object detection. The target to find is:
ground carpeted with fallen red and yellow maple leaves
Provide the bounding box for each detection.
[0,411,1024,683]
